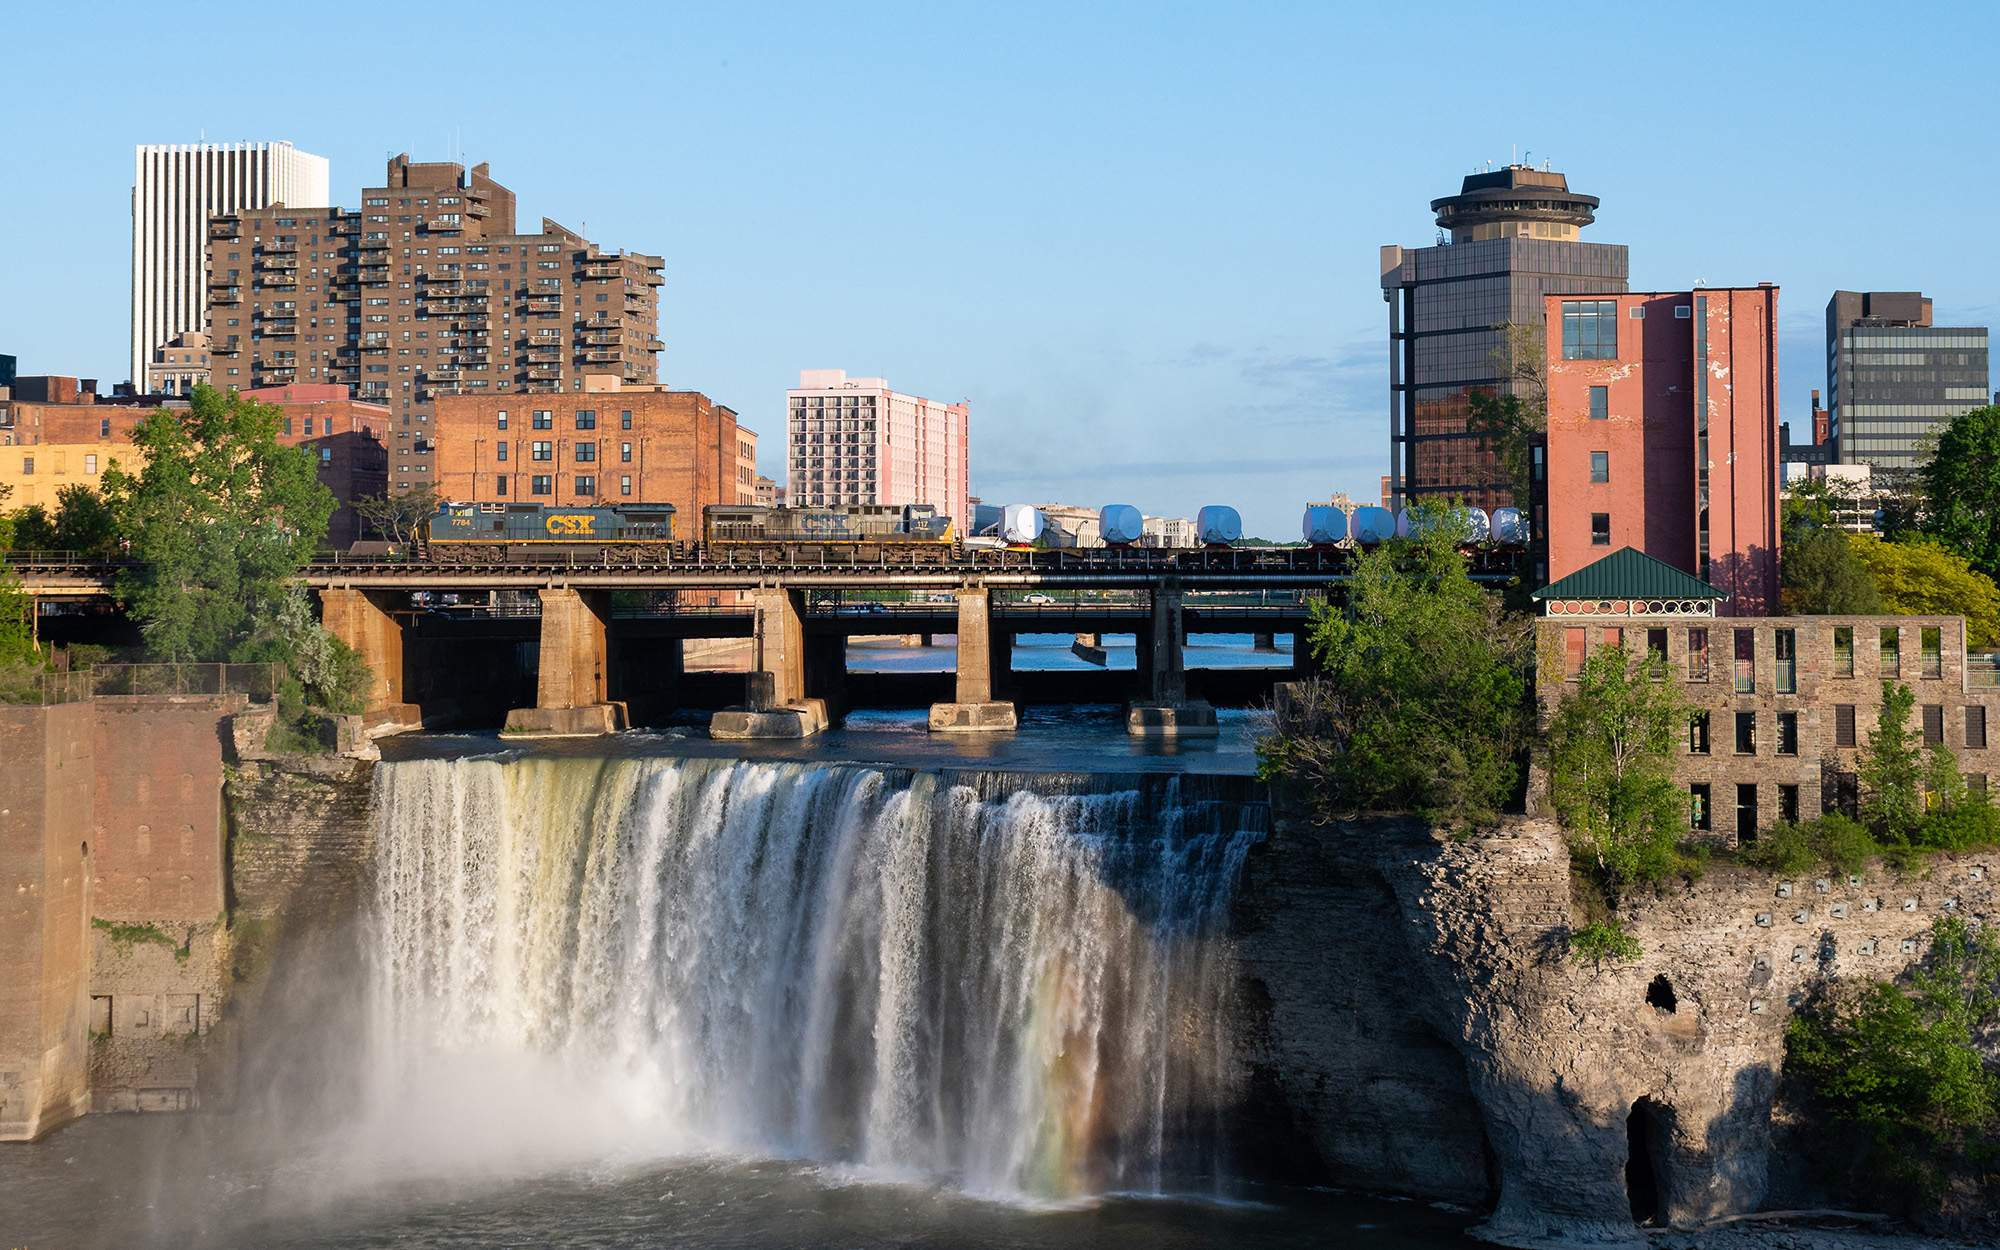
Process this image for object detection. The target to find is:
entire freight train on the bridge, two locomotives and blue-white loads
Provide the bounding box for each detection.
[424,502,1528,564]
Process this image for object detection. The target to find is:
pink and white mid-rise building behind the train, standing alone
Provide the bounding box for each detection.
[786,368,972,532]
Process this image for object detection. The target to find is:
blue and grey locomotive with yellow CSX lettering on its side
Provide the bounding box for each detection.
[426,504,674,564]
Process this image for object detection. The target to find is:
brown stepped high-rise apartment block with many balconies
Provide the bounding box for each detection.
[208,154,664,490]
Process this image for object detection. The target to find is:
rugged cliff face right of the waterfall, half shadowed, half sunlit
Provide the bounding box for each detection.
[1238,818,2000,1246]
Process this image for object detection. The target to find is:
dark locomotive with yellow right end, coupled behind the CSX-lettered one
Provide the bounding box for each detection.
[702,504,958,564]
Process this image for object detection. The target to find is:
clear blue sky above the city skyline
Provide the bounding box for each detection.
[0,0,2000,538]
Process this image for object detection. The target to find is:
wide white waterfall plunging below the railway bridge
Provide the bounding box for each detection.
[368,758,1264,1200]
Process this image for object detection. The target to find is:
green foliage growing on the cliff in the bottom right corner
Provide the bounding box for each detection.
[1784,916,2000,1198]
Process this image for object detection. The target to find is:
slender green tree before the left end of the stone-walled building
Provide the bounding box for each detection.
[1546,646,1692,894]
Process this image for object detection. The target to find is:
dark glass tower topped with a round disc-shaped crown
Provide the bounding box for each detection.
[1382,164,1628,508]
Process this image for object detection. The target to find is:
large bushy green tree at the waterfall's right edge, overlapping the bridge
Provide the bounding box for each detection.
[1258,508,1530,826]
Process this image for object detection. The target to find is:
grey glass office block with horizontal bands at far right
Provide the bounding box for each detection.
[1826,290,1990,468]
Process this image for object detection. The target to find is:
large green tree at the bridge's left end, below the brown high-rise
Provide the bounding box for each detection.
[104,386,334,662]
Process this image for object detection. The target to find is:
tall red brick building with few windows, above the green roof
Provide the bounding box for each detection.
[1536,284,1778,616]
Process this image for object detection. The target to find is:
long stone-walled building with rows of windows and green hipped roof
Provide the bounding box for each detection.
[1536,548,2000,844]
